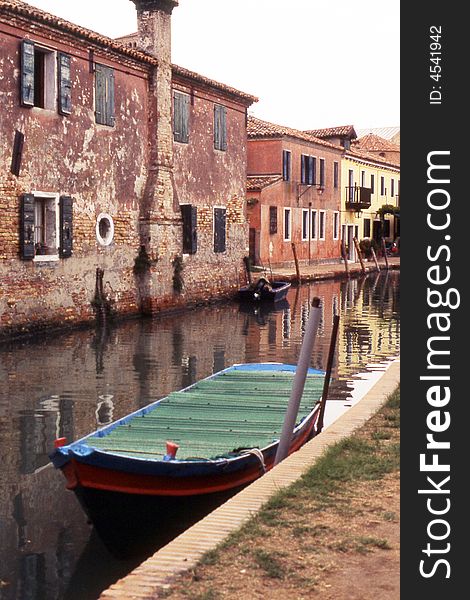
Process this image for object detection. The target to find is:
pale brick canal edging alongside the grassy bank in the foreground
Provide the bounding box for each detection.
[100,359,400,600]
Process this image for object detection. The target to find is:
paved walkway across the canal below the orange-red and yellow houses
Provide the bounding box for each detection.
[253,256,400,282]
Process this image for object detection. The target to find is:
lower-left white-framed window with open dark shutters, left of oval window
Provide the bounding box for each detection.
[20,192,73,261]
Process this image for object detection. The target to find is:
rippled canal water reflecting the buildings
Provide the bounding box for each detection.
[0,271,400,600]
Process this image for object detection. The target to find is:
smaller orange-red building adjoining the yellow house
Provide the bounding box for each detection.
[247,117,342,266]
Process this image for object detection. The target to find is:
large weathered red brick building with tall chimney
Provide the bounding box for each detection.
[0,0,256,334]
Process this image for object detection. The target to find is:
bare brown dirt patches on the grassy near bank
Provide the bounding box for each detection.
[160,394,400,600]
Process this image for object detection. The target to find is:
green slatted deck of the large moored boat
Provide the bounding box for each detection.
[87,369,324,460]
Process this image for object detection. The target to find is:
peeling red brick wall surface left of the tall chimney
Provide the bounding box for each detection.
[0,17,148,334]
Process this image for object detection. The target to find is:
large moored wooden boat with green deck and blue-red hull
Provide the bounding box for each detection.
[50,363,325,543]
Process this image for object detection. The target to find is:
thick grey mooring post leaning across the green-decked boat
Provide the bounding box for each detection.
[274,297,321,465]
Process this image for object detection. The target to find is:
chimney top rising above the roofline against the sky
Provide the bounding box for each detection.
[131,0,179,64]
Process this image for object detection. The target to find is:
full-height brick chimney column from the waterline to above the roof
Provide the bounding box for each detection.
[131,0,182,312]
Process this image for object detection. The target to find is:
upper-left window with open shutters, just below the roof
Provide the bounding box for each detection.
[21,40,65,114]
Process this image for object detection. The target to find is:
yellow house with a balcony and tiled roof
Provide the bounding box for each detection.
[308,125,400,260]
